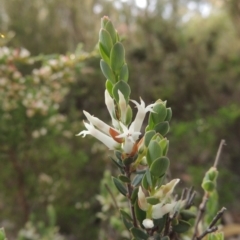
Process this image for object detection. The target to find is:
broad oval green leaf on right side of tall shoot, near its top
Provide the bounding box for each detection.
[110,42,125,74]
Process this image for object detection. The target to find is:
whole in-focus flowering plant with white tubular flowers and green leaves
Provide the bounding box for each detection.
[78,17,225,240]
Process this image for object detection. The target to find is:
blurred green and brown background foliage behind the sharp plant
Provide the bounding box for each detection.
[0,0,240,240]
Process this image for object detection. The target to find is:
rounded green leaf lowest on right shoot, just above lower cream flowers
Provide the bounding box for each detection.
[150,157,170,177]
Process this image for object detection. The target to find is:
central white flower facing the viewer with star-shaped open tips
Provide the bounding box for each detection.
[116,122,141,154]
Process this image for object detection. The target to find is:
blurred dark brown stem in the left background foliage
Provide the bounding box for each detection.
[9,151,29,222]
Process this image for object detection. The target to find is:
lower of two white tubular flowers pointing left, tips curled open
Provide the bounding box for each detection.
[76,122,119,150]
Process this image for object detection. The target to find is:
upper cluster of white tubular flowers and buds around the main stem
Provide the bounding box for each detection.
[77,90,155,156]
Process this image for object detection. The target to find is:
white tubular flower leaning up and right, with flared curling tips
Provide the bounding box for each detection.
[131,98,156,132]
